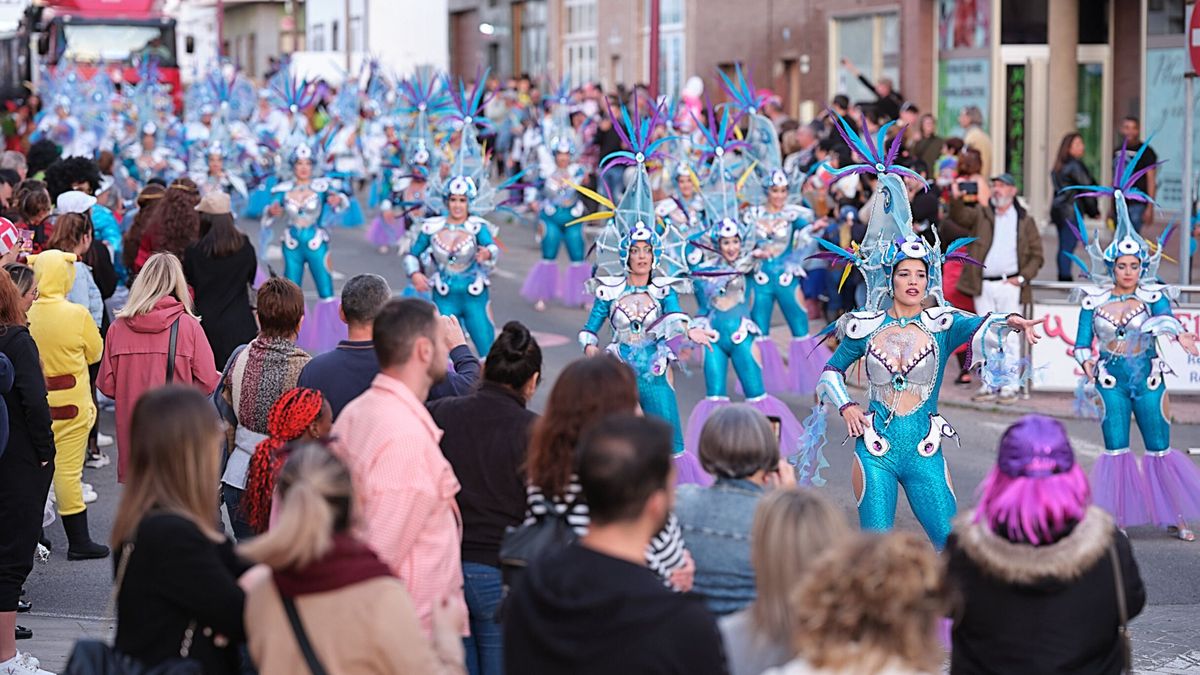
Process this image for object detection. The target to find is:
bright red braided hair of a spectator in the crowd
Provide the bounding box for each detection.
[241,387,334,534]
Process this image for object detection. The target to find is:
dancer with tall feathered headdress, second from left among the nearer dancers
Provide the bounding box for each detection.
[403,76,511,354]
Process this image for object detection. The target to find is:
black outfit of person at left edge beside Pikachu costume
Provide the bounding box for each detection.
[0,325,54,611]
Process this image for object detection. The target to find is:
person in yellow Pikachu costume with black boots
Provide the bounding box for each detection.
[29,250,108,560]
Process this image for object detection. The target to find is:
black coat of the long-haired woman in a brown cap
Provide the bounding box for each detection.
[184,239,258,364]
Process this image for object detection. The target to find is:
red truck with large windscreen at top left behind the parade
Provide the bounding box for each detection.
[23,0,182,110]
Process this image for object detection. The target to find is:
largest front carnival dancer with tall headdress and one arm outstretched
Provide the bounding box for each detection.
[818,117,1040,549]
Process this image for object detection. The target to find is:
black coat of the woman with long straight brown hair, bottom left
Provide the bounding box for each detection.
[113,512,250,675]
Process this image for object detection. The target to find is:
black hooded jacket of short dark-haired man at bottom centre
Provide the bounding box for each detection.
[504,544,726,675]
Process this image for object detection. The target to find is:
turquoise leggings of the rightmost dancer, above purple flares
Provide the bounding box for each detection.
[1096,354,1171,452]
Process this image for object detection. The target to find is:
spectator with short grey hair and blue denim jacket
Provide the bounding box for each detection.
[676,404,796,616]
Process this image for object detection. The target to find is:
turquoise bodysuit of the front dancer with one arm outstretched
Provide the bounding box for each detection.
[818,306,1007,549]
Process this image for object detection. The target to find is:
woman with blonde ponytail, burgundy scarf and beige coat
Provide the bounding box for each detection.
[240,442,464,675]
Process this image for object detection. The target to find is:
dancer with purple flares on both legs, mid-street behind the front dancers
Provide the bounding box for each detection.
[521,92,592,311]
